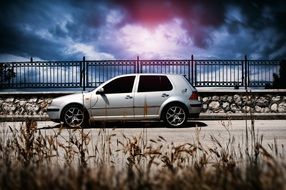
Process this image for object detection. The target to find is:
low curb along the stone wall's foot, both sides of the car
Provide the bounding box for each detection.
[0,113,286,122]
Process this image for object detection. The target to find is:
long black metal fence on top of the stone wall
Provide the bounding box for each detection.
[0,56,282,89]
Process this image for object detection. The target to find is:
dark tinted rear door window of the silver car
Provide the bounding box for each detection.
[138,75,173,92]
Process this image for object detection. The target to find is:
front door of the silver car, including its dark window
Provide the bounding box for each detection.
[91,75,135,119]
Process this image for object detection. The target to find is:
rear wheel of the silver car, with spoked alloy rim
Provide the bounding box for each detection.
[162,104,188,127]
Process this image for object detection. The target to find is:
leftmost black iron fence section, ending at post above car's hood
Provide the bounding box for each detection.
[0,61,82,88]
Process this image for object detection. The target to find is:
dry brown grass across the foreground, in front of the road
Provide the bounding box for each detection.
[0,121,286,189]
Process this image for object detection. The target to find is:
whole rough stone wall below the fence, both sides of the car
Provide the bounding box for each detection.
[0,90,286,116]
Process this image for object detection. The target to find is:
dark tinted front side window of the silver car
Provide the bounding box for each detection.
[103,76,135,94]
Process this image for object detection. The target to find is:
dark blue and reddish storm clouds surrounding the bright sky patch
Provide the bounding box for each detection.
[0,0,286,59]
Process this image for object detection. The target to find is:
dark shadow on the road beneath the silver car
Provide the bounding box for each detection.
[38,121,208,130]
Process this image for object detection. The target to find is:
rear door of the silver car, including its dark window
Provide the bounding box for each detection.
[134,75,173,118]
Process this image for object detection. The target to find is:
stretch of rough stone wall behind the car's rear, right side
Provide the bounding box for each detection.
[200,92,286,114]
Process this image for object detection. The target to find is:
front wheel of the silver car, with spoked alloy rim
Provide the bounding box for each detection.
[62,104,88,127]
